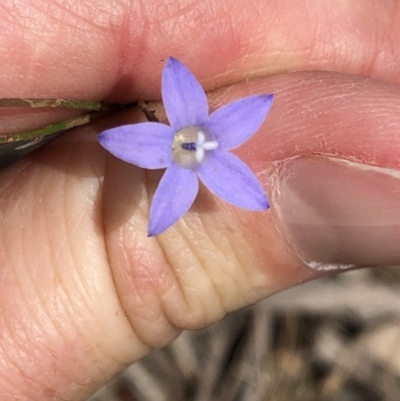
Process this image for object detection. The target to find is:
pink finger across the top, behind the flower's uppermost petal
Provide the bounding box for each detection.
[0,0,400,104]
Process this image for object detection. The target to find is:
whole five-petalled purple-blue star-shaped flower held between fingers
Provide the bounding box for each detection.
[98,57,273,236]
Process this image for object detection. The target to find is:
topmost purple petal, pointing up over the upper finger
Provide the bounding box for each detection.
[161,57,208,131]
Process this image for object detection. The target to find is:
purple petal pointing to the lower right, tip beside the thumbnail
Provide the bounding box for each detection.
[197,150,269,210]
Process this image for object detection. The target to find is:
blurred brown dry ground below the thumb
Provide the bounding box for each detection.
[90,267,400,401]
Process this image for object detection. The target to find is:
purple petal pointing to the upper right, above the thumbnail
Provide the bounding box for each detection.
[203,94,273,149]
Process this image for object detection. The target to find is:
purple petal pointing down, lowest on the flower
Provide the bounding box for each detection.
[148,163,199,237]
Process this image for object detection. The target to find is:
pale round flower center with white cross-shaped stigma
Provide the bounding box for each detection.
[172,127,218,167]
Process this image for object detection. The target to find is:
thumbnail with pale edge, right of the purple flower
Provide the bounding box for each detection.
[272,156,400,270]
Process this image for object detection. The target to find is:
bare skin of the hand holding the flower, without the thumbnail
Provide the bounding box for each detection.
[0,0,400,400]
